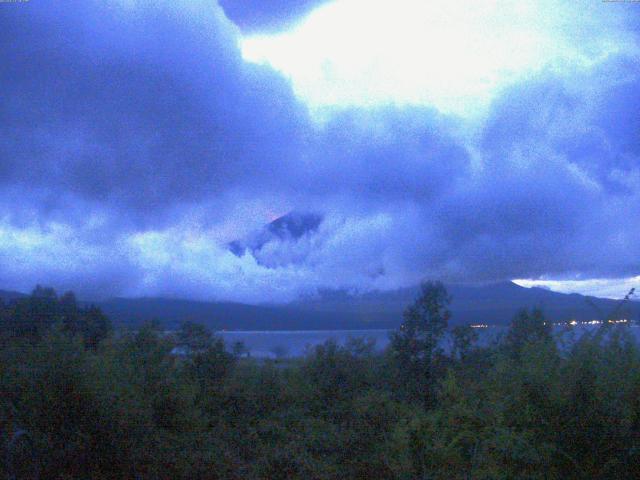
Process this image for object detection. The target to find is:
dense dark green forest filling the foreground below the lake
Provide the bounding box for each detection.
[0,282,640,479]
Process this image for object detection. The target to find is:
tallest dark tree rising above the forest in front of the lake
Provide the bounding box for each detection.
[391,281,451,404]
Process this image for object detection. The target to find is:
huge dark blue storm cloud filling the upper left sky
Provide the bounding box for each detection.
[0,2,305,230]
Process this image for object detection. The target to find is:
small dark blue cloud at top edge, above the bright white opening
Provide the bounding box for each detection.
[220,0,328,32]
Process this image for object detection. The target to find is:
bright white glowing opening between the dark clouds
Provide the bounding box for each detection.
[242,0,610,116]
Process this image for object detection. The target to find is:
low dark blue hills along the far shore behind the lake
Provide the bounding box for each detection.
[94,282,640,330]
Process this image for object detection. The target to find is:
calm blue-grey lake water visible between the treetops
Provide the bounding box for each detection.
[218,325,640,358]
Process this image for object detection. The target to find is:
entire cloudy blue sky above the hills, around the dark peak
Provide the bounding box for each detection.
[0,0,640,302]
